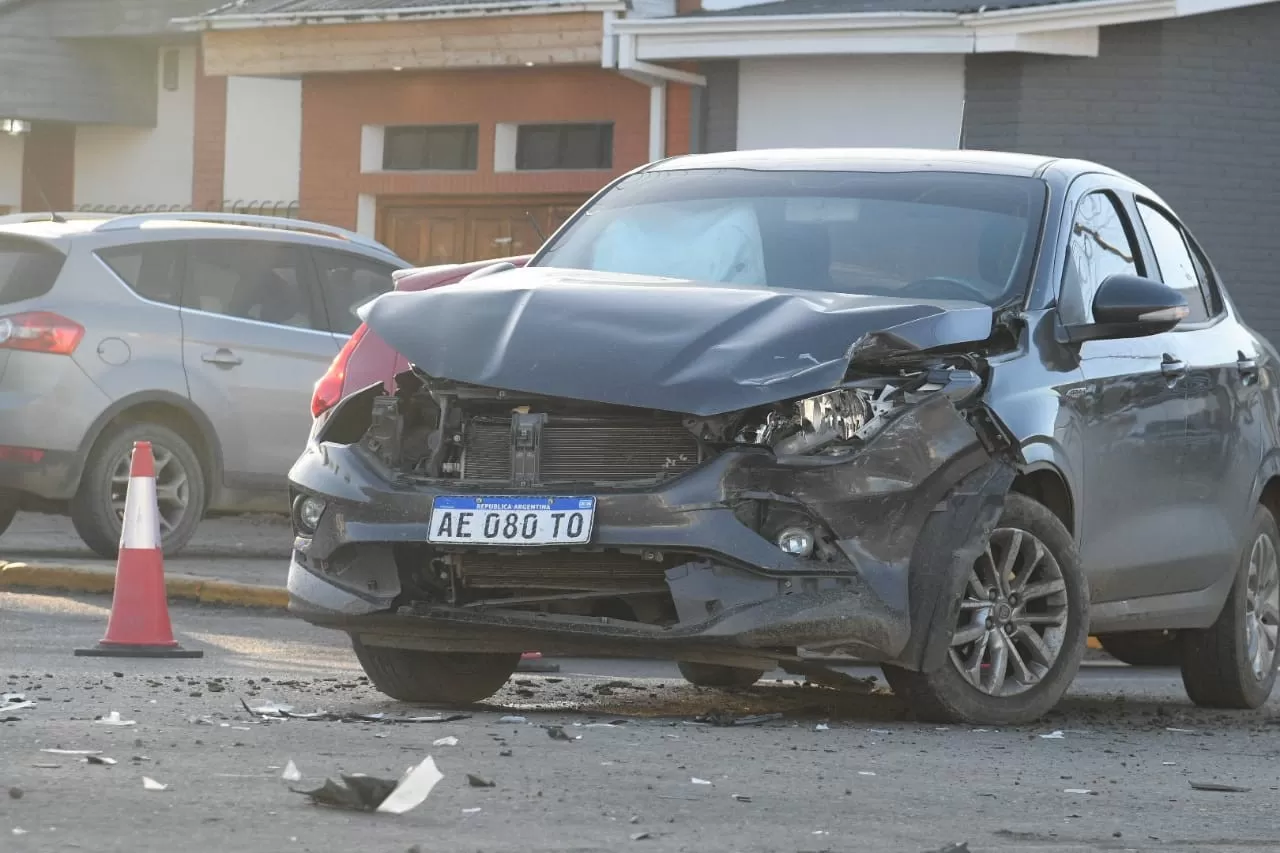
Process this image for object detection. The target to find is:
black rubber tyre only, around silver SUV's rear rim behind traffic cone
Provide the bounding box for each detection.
[70,424,206,560]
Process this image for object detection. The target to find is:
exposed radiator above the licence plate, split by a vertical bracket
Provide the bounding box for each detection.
[462,418,699,483]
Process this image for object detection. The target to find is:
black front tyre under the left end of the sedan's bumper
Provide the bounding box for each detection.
[351,637,520,706]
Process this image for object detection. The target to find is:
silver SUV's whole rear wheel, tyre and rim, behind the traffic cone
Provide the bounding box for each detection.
[70,424,205,558]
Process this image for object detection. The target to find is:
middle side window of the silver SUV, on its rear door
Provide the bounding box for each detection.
[182,240,324,329]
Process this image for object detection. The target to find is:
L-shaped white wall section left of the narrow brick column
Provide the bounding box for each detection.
[76,46,196,206]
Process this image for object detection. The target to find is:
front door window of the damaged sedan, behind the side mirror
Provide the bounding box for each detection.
[1062,191,1142,323]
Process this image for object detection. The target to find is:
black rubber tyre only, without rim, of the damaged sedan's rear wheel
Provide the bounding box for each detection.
[1180,507,1280,708]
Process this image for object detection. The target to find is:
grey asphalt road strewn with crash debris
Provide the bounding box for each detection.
[0,593,1280,853]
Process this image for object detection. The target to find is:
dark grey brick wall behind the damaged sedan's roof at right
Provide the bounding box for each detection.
[964,4,1280,343]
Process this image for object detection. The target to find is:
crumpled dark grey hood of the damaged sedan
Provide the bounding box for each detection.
[360,268,992,416]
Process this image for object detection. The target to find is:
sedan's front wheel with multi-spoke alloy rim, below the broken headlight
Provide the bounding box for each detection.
[884,493,1089,725]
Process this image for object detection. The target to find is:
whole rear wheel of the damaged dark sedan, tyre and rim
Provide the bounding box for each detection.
[1181,507,1280,710]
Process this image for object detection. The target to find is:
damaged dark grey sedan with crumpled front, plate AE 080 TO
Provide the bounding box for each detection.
[289,151,1280,724]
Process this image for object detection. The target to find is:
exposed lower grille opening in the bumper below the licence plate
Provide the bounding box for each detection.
[461,551,675,592]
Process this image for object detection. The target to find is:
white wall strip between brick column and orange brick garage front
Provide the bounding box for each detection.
[223,77,302,201]
